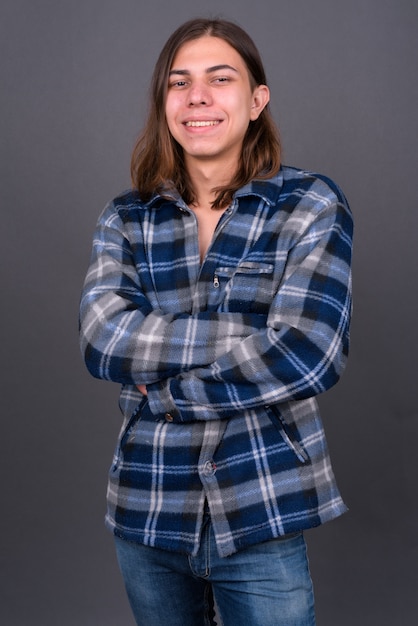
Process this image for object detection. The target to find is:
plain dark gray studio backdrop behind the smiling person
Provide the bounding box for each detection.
[0,0,418,626]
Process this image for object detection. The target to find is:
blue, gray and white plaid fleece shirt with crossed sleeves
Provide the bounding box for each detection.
[80,167,352,556]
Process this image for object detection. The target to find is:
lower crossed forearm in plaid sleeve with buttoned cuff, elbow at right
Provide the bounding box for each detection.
[148,310,349,422]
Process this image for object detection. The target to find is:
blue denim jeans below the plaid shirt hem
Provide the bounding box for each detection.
[115,510,315,626]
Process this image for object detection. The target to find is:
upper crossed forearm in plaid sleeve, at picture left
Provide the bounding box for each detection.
[80,293,265,384]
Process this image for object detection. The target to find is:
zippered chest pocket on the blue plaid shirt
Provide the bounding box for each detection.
[214,261,275,313]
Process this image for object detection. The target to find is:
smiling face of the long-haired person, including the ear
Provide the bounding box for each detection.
[165,36,269,169]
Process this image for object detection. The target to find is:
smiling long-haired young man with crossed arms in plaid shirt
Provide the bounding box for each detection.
[81,19,352,626]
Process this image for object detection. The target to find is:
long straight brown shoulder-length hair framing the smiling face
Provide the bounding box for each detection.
[131,18,281,208]
